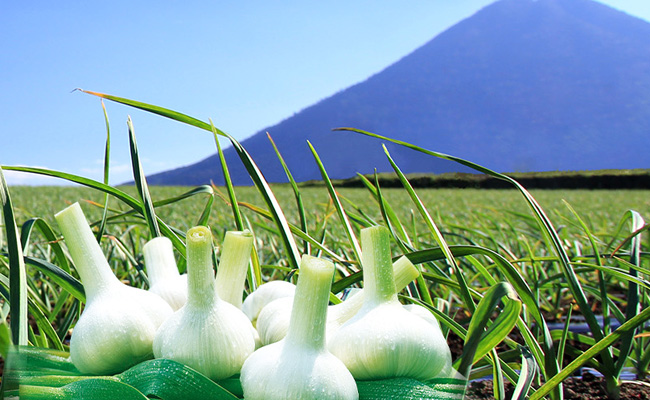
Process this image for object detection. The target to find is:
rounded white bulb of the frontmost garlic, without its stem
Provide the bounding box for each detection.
[241,339,359,400]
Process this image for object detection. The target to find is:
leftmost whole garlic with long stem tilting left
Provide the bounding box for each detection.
[55,203,172,375]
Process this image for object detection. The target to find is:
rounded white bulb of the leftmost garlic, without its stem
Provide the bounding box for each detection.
[70,285,172,375]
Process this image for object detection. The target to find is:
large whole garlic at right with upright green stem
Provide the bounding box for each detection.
[328,226,451,380]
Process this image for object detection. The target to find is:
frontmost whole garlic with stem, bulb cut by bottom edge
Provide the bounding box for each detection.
[240,255,359,400]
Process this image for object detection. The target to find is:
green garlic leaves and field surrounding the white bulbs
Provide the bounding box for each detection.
[0,91,650,399]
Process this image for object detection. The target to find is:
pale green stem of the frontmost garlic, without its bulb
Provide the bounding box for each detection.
[287,255,334,349]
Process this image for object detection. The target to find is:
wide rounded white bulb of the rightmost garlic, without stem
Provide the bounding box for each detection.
[328,302,451,380]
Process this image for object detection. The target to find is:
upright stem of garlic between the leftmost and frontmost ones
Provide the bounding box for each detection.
[186,226,217,308]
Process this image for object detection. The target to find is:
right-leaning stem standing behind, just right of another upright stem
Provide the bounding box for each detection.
[217,230,253,309]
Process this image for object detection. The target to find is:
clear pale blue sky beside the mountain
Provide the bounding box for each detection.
[0,0,650,185]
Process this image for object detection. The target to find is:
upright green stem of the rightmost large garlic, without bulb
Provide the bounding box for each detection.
[361,226,397,304]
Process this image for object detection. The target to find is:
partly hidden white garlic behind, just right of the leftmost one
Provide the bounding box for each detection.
[142,236,187,311]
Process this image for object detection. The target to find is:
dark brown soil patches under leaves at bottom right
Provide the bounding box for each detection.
[465,372,650,400]
